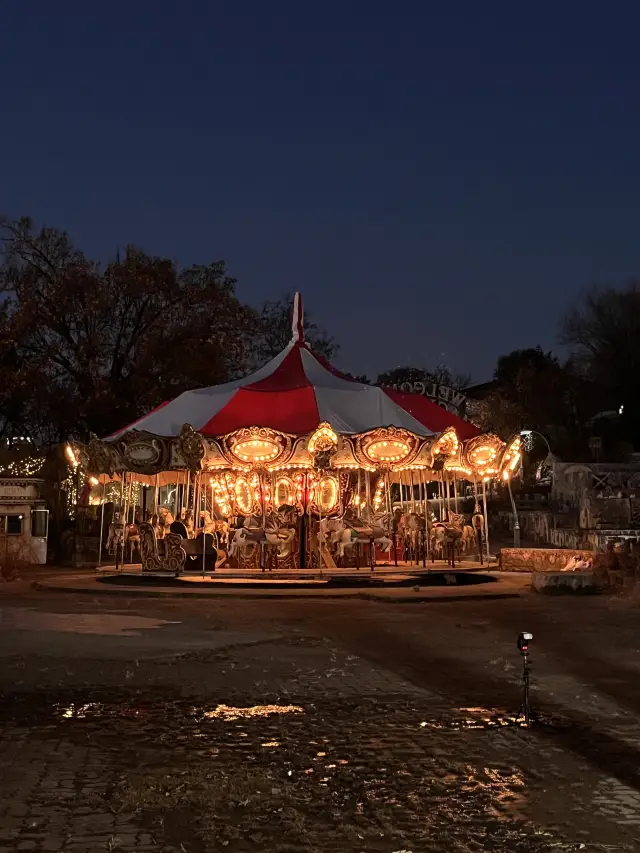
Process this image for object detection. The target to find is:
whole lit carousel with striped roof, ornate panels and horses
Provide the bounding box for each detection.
[72,294,521,575]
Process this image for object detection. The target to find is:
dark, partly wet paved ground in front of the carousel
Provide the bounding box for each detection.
[0,585,640,853]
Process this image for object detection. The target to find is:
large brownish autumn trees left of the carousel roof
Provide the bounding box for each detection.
[0,219,256,443]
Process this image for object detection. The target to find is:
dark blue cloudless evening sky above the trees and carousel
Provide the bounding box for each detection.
[0,0,640,381]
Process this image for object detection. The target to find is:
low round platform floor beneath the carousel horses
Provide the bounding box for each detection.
[96,557,497,586]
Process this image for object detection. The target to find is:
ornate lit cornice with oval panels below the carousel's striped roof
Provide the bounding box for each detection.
[74,423,521,479]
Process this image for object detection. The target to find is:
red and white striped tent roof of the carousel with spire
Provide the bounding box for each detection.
[109,293,479,441]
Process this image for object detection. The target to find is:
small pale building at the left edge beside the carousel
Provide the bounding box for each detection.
[0,477,49,564]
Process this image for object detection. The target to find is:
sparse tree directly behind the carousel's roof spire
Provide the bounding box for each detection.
[253,293,338,367]
